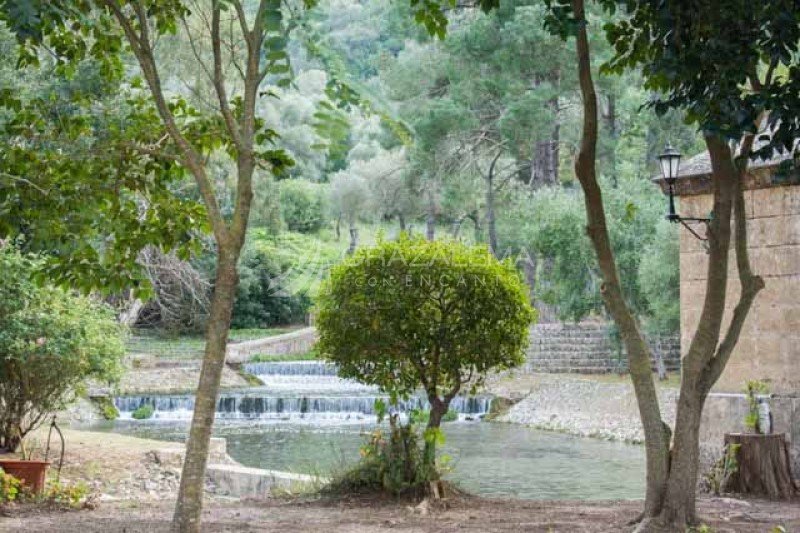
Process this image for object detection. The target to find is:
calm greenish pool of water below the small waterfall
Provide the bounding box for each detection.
[83,420,644,500]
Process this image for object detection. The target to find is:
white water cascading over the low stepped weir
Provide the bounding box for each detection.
[114,361,491,422]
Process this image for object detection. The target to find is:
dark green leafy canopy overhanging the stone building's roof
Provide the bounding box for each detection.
[606,0,800,157]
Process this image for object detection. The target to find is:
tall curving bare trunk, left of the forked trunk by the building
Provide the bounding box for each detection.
[572,0,670,516]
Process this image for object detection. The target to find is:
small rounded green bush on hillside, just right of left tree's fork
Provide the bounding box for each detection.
[280,179,327,233]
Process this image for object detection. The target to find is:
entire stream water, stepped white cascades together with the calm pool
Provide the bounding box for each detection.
[93,361,645,499]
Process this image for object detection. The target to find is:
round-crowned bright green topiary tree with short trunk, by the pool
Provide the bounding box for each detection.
[317,235,536,466]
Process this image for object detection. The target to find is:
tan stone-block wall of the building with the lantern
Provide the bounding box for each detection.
[680,186,800,394]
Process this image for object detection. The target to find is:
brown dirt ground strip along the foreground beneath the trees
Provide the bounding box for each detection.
[0,498,800,533]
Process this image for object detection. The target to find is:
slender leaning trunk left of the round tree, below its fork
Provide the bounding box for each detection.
[173,247,240,533]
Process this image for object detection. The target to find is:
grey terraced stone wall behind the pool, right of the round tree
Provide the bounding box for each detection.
[522,323,680,374]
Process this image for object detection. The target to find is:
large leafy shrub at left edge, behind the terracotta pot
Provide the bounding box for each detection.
[0,246,124,451]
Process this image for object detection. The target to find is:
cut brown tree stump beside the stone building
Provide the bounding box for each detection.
[722,433,798,500]
